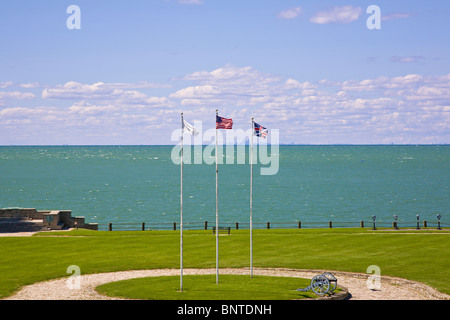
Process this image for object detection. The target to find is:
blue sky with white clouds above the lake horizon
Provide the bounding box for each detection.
[0,0,450,145]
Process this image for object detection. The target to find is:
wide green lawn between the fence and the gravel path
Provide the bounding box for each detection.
[0,228,450,297]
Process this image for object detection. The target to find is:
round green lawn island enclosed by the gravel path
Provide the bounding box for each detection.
[97,274,317,300]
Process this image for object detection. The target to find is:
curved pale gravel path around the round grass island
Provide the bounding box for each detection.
[4,268,450,300]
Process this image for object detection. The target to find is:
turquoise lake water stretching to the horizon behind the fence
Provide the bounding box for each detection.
[0,145,450,227]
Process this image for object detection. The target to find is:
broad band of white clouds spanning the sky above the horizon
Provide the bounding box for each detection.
[0,65,450,144]
